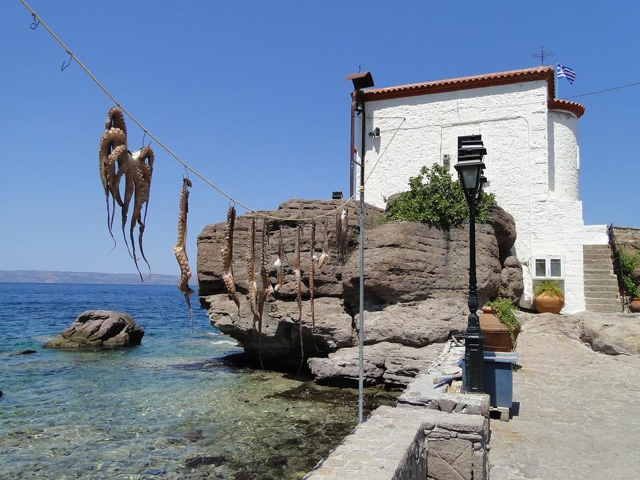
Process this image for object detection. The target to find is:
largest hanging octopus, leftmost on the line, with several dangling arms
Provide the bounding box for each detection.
[98,107,155,280]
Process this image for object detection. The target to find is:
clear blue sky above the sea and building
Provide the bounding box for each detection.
[0,0,640,276]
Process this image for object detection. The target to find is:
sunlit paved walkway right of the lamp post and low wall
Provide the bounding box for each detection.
[489,316,640,480]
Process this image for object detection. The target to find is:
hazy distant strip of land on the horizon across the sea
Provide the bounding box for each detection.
[0,270,180,285]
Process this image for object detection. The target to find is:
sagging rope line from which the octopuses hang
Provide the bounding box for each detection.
[20,0,355,222]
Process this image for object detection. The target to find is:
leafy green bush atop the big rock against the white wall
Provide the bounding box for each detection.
[385,165,496,229]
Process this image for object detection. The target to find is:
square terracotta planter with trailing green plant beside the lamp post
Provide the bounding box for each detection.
[480,297,520,352]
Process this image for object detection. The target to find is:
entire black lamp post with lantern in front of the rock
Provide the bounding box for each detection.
[454,135,487,393]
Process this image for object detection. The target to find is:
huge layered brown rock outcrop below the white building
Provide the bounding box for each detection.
[198,200,512,384]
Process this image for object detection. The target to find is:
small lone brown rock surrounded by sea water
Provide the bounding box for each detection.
[44,310,144,349]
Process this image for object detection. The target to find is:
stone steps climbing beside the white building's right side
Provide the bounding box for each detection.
[583,245,622,313]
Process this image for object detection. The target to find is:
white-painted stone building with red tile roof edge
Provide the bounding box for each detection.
[354,67,607,313]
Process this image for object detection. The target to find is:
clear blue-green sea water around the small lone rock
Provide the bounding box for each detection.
[0,283,358,480]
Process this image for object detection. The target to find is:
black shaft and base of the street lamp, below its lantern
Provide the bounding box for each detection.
[464,195,484,393]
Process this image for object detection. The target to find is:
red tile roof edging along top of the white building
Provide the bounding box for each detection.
[362,67,584,118]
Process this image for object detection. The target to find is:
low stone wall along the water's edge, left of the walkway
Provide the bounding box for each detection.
[304,345,490,480]
